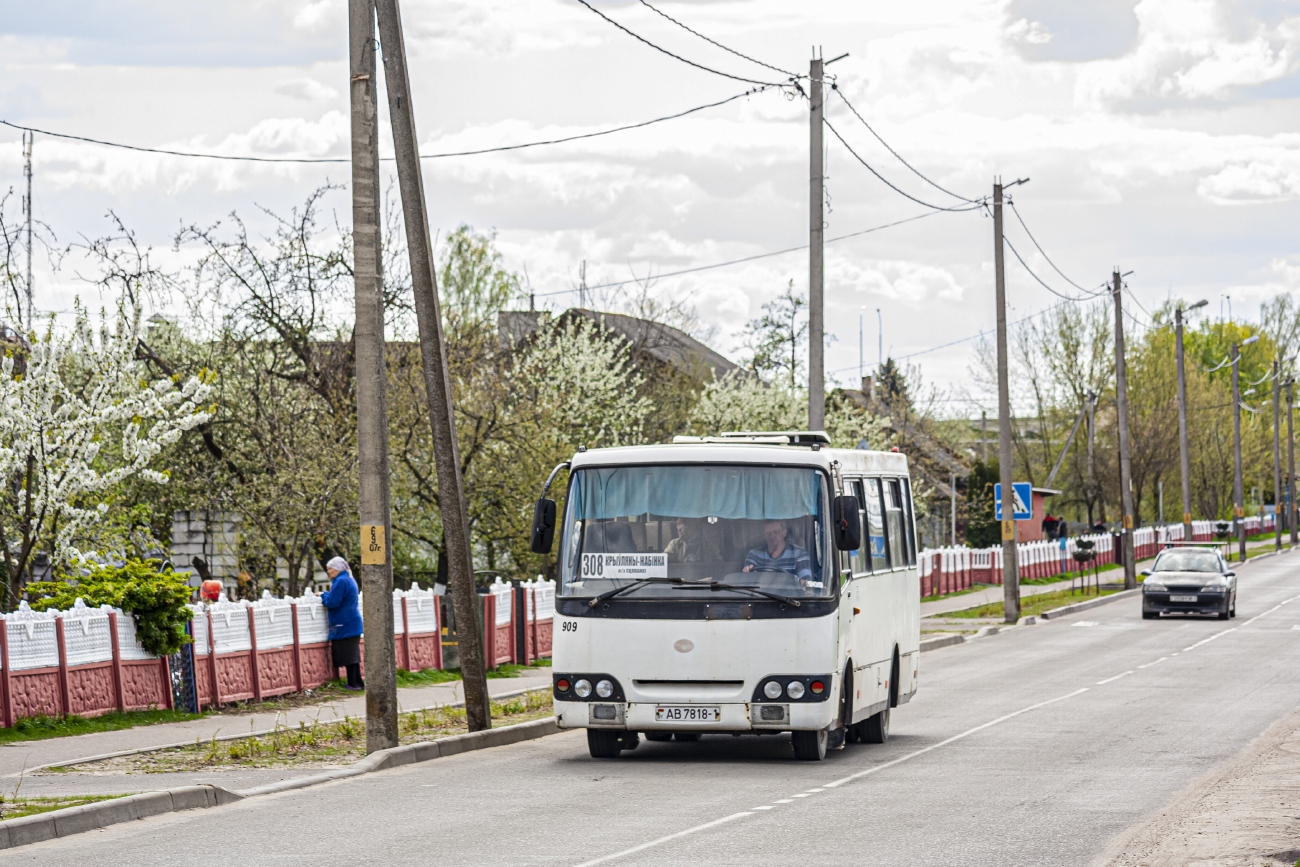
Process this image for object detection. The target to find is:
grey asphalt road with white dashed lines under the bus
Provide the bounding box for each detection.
[17,555,1300,867]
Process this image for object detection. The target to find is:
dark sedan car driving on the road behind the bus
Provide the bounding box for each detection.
[1141,547,1236,620]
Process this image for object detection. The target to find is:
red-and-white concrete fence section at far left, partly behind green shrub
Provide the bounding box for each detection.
[0,599,172,727]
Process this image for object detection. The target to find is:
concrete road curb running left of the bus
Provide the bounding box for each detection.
[0,717,562,849]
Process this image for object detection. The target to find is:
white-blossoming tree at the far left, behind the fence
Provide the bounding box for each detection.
[0,304,209,610]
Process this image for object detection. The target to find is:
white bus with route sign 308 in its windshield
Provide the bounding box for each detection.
[532,432,920,760]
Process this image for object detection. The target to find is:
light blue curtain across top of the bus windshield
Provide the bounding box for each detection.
[573,465,822,520]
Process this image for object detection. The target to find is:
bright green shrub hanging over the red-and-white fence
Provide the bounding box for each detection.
[27,560,191,656]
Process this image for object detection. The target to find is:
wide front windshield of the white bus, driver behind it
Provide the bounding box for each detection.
[560,465,835,599]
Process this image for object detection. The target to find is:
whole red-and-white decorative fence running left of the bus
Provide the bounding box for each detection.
[0,580,555,727]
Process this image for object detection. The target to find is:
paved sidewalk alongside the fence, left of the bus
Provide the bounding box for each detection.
[0,669,551,779]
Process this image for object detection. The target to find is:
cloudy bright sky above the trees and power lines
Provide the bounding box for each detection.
[0,0,1300,413]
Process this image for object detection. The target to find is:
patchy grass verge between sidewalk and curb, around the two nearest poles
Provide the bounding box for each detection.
[65,689,555,773]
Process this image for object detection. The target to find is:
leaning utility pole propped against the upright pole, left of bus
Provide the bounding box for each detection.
[379,0,493,732]
